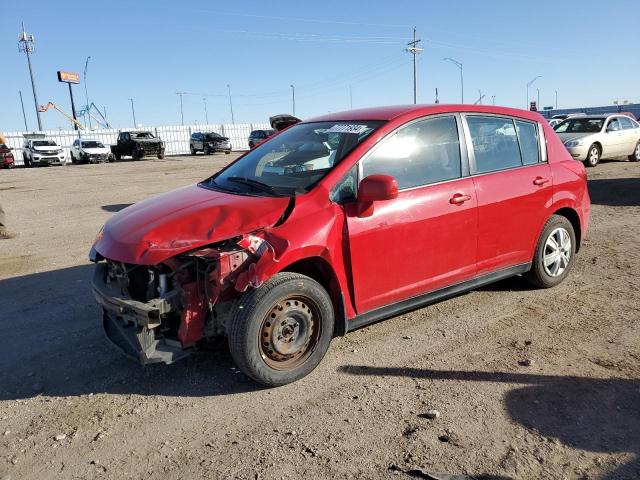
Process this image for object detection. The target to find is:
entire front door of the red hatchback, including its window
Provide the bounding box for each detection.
[346,115,477,314]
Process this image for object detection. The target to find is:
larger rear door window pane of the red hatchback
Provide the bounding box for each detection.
[467,116,522,173]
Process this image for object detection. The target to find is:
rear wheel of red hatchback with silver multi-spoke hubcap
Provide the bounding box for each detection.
[525,215,577,288]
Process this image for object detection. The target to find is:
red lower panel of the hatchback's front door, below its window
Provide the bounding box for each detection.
[346,178,477,313]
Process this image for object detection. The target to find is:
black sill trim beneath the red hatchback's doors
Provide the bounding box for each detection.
[347,263,531,332]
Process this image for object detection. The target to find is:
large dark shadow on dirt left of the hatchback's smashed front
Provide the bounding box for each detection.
[0,264,261,400]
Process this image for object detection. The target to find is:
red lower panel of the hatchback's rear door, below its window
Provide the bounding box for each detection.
[473,163,553,275]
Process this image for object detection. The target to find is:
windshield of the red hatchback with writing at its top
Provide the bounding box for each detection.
[201,121,382,196]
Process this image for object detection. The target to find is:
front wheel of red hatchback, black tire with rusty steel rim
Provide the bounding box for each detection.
[228,272,334,387]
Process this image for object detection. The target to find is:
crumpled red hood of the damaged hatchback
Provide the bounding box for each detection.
[94,185,289,265]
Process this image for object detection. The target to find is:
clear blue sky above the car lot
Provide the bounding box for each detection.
[0,0,640,131]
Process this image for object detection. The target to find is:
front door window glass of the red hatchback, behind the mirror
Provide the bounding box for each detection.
[362,116,462,189]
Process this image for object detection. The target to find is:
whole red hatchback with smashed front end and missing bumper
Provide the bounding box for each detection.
[90,105,590,386]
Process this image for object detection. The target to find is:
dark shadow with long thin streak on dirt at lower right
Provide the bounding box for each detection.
[340,365,640,480]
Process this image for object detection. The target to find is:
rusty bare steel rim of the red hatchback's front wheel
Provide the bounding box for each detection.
[260,297,320,370]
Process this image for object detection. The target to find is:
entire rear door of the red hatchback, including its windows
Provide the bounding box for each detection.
[464,114,553,275]
